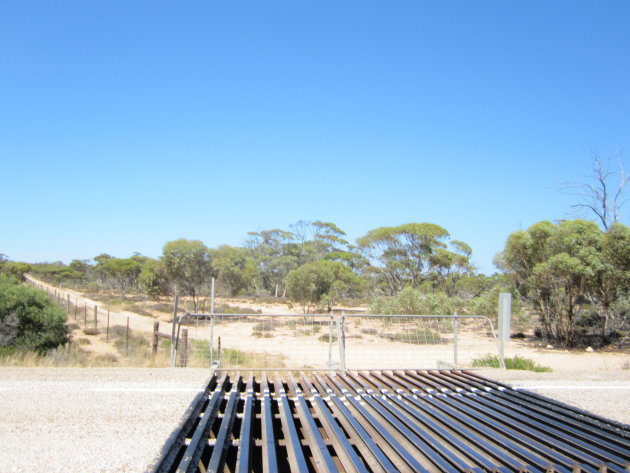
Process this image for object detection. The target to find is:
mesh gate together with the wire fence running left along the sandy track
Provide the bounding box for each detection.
[27,278,501,370]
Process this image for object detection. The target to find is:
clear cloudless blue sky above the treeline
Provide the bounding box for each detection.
[0,0,630,273]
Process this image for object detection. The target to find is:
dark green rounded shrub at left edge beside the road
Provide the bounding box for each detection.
[0,276,68,353]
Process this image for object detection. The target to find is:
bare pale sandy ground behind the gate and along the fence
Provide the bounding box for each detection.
[29,277,630,373]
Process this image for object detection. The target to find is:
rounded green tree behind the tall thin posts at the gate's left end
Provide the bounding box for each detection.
[162,238,213,310]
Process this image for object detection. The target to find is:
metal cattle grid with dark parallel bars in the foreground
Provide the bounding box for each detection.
[153,370,630,473]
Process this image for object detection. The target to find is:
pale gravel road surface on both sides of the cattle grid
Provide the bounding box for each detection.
[0,368,630,473]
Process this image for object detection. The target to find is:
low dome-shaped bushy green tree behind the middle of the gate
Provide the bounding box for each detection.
[287,260,364,314]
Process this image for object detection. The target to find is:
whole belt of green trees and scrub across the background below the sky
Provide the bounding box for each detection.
[0,160,630,351]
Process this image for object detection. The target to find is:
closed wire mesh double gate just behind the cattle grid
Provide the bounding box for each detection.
[171,314,498,370]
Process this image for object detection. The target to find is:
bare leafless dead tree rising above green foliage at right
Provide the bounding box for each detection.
[562,151,629,230]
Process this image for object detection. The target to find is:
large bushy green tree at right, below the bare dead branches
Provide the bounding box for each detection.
[500,220,630,346]
